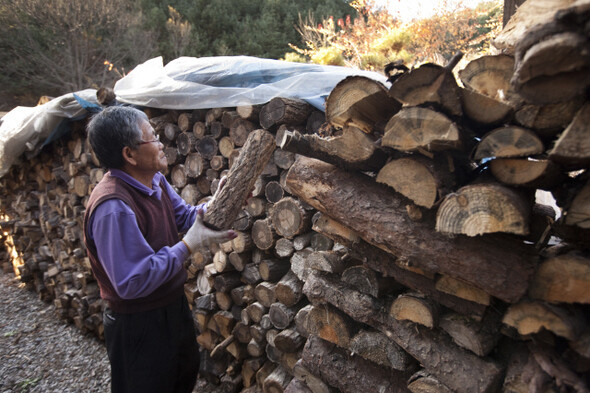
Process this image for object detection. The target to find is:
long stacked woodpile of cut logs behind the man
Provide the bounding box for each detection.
[0,2,590,393]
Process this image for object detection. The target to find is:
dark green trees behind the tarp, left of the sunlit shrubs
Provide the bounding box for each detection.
[140,0,354,61]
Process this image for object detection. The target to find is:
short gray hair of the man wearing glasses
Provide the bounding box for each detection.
[86,106,149,169]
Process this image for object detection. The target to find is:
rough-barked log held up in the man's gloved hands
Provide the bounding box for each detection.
[204,130,275,229]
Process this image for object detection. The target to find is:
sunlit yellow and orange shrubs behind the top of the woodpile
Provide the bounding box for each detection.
[284,0,502,70]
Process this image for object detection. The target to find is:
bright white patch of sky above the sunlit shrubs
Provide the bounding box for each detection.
[375,0,494,22]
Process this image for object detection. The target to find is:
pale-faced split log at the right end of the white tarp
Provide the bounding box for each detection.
[326,76,401,134]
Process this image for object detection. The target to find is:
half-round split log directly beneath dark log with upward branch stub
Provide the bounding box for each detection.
[381,107,464,152]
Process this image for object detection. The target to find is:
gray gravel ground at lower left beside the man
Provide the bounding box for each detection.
[0,272,110,393]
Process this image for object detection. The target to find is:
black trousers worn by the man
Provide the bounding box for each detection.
[103,295,199,393]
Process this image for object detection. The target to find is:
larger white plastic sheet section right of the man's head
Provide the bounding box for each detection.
[114,56,394,110]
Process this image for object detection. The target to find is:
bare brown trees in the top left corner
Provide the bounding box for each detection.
[0,0,154,104]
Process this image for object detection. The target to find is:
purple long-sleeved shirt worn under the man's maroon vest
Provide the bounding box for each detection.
[88,169,206,299]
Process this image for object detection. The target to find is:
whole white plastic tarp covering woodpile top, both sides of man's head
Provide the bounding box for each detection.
[0,56,387,177]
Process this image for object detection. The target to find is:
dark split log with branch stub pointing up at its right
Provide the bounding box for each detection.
[389,53,463,116]
